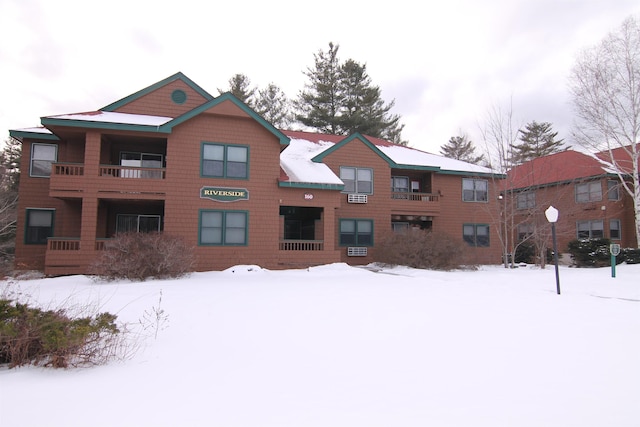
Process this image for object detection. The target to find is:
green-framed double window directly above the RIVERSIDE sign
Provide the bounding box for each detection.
[201,143,249,179]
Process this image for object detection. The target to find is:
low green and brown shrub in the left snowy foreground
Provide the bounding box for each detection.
[0,297,121,368]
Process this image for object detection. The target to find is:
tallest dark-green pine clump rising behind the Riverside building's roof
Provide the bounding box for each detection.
[296,43,406,144]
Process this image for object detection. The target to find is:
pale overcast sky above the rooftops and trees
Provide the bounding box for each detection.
[0,0,640,153]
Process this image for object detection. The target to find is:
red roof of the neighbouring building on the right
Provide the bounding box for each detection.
[505,150,610,190]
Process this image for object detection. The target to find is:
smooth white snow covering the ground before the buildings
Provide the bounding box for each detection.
[0,264,640,427]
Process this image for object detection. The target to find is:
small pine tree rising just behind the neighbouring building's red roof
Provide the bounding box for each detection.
[510,120,566,164]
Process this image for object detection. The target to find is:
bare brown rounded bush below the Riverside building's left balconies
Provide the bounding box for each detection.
[91,233,193,281]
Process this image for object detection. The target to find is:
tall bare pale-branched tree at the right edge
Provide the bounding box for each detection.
[570,17,640,248]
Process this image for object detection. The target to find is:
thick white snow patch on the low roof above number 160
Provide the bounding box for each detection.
[280,138,344,185]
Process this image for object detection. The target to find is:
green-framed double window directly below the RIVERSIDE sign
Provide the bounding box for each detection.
[199,210,248,246]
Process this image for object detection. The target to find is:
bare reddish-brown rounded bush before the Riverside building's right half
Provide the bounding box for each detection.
[374,230,464,270]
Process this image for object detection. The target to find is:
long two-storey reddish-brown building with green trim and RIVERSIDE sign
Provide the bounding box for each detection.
[10,73,501,275]
